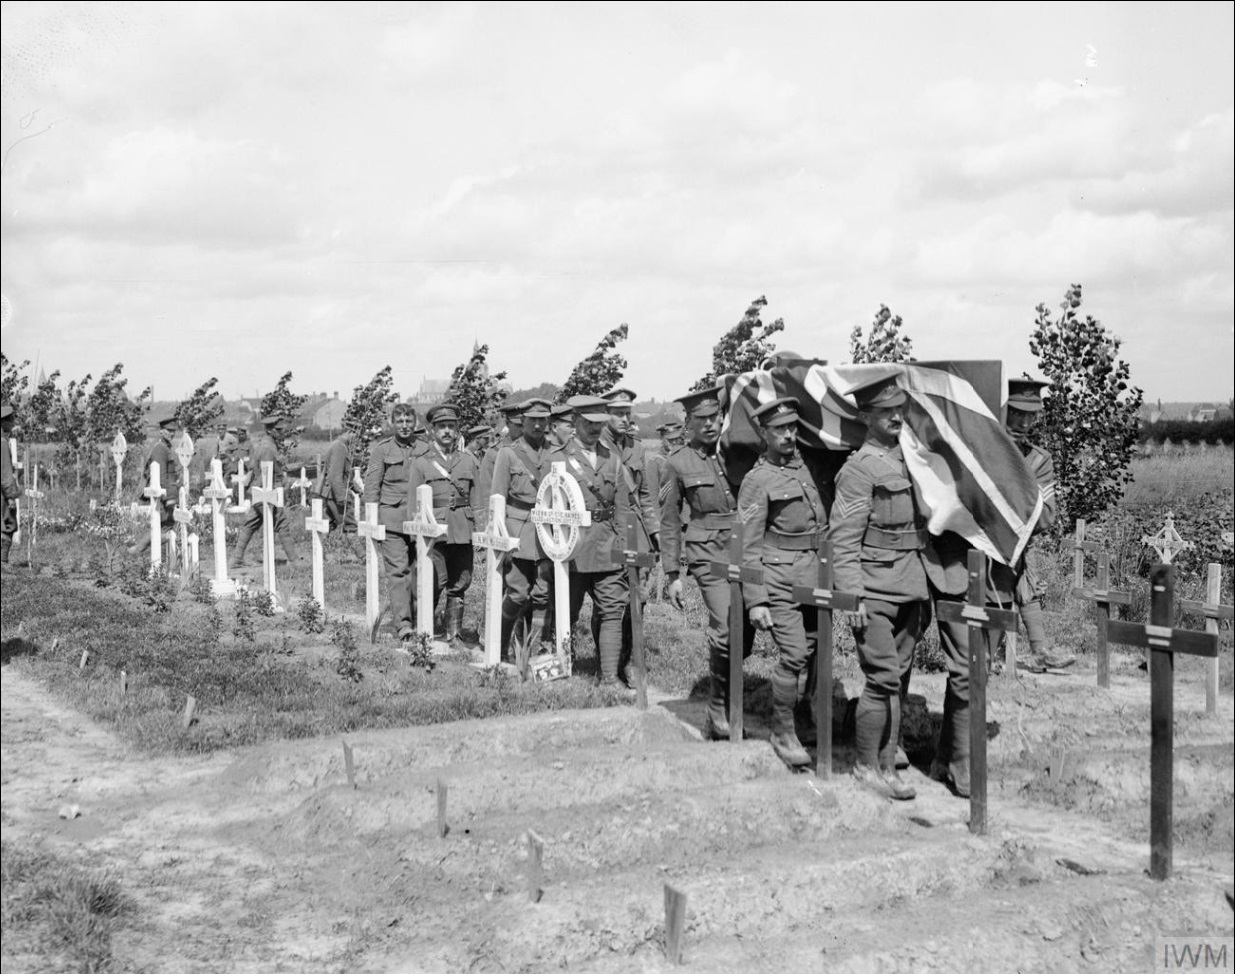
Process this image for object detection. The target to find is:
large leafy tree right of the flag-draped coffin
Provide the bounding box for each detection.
[1029,284,1144,532]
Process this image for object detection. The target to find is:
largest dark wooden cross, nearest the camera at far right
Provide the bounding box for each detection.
[1108,564,1218,879]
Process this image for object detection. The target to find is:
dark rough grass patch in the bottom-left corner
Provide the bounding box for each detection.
[0,839,133,974]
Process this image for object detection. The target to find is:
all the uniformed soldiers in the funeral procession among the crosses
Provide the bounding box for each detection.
[4,367,1068,800]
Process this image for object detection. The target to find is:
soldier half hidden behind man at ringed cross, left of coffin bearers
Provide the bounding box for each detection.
[602,389,661,685]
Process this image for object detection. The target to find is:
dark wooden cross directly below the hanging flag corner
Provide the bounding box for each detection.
[935,549,1020,836]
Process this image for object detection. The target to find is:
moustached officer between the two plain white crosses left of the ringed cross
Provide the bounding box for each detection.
[408,402,480,648]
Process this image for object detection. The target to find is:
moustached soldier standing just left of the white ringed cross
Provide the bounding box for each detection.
[493,399,553,658]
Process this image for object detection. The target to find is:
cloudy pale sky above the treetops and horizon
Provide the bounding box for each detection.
[0,0,1235,401]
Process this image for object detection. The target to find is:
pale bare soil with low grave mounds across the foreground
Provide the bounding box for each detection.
[0,641,1235,974]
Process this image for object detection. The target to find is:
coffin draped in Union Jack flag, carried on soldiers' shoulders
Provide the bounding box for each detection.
[721,359,1044,564]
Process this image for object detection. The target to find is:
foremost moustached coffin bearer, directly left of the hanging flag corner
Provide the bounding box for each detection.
[827,379,931,801]
